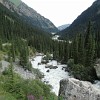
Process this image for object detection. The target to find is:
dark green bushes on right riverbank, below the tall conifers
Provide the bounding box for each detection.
[67,59,96,82]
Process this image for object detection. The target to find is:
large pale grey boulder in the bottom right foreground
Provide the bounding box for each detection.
[59,78,100,100]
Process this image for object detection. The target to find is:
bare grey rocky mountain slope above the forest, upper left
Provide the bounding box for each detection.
[0,0,58,32]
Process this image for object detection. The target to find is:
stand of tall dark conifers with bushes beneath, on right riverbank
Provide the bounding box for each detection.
[65,22,100,82]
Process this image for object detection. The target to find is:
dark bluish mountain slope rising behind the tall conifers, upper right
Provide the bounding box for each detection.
[59,0,100,37]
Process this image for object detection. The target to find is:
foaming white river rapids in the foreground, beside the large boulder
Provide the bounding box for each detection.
[31,56,100,95]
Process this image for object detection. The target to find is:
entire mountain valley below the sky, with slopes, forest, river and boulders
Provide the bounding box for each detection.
[0,0,100,100]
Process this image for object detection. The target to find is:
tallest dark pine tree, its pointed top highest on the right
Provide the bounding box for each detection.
[85,22,95,67]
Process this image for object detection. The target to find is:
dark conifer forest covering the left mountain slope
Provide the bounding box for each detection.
[0,4,69,63]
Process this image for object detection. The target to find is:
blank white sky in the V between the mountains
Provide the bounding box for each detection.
[22,0,95,26]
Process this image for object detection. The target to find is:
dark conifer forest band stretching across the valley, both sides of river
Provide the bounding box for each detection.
[0,0,100,80]
